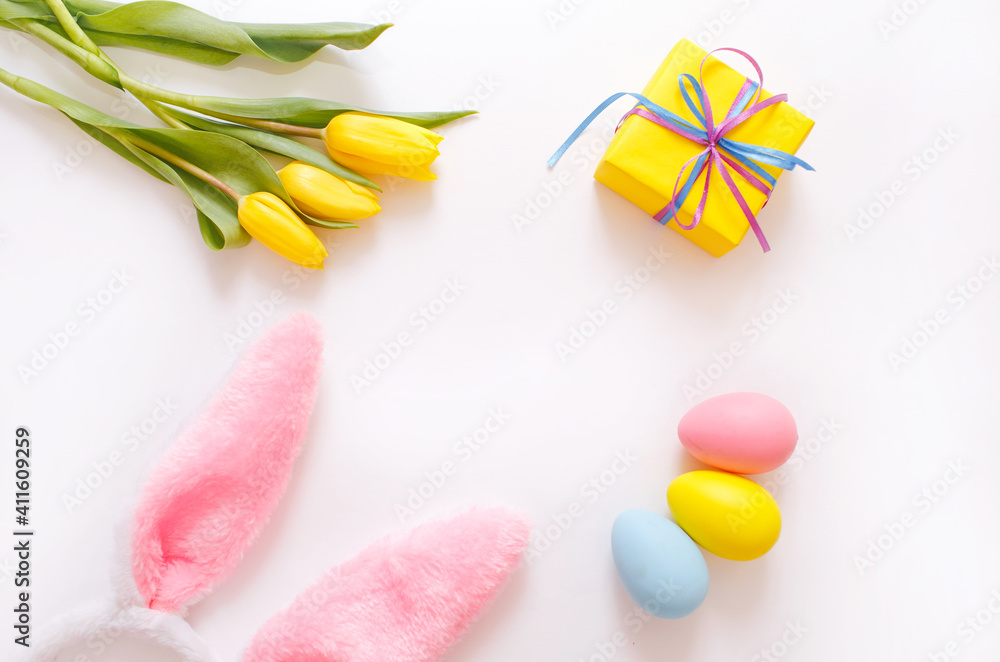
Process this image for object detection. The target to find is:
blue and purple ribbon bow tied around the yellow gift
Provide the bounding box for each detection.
[549,48,813,253]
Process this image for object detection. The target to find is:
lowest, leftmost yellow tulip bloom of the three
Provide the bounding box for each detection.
[238,191,327,269]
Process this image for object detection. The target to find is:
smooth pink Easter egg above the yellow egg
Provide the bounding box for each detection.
[677,393,799,474]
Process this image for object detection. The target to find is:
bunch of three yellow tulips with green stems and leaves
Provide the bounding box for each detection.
[0,0,469,269]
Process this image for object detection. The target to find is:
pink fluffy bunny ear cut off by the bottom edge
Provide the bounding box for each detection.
[243,508,531,662]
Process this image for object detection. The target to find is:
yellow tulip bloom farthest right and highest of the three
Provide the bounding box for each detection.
[323,112,444,181]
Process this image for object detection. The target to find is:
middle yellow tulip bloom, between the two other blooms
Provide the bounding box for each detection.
[278,162,381,221]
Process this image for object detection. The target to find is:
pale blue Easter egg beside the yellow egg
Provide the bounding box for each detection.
[611,509,708,618]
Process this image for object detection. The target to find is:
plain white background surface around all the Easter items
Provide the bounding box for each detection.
[0,0,1000,662]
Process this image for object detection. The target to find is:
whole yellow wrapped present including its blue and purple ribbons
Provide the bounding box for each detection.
[549,39,813,257]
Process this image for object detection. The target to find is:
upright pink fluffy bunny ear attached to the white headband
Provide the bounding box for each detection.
[132,313,323,612]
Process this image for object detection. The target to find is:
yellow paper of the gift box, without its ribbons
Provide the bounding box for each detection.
[594,39,813,257]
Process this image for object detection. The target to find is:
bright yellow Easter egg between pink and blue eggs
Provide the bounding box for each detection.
[667,471,781,561]
